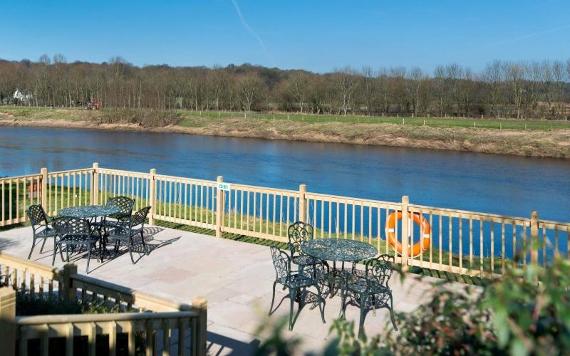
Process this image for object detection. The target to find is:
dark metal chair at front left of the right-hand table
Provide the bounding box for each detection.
[269,246,326,330]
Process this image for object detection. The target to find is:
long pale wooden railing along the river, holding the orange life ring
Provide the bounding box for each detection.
[0,163,570,276]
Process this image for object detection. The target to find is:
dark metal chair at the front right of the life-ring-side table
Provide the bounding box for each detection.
[341,254,398,335]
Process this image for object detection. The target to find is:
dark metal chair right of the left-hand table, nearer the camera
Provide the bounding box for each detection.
[107,206,150,264]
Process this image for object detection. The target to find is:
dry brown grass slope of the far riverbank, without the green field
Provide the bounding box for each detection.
[0,107,570,159]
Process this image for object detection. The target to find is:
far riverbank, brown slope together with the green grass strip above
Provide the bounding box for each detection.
[0,107,570,158]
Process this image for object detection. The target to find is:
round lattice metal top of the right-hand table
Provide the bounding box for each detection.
[301,238,378,262]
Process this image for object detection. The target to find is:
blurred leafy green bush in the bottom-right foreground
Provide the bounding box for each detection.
[385,258,570,355]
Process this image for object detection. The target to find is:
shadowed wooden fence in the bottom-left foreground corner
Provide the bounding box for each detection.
[0,253,207,355]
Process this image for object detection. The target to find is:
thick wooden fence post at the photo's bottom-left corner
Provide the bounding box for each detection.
[0,287,17,355]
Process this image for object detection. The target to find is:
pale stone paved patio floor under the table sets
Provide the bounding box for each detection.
[0,227,452,355]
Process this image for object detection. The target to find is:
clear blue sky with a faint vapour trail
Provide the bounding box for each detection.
[0,0,570,72]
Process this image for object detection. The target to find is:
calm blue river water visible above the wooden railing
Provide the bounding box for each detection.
[0,127,570,221]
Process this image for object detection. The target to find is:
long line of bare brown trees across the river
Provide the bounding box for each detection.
[0,55,570,120]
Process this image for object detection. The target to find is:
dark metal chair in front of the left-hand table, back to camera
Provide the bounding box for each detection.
[52,217,102,273]
